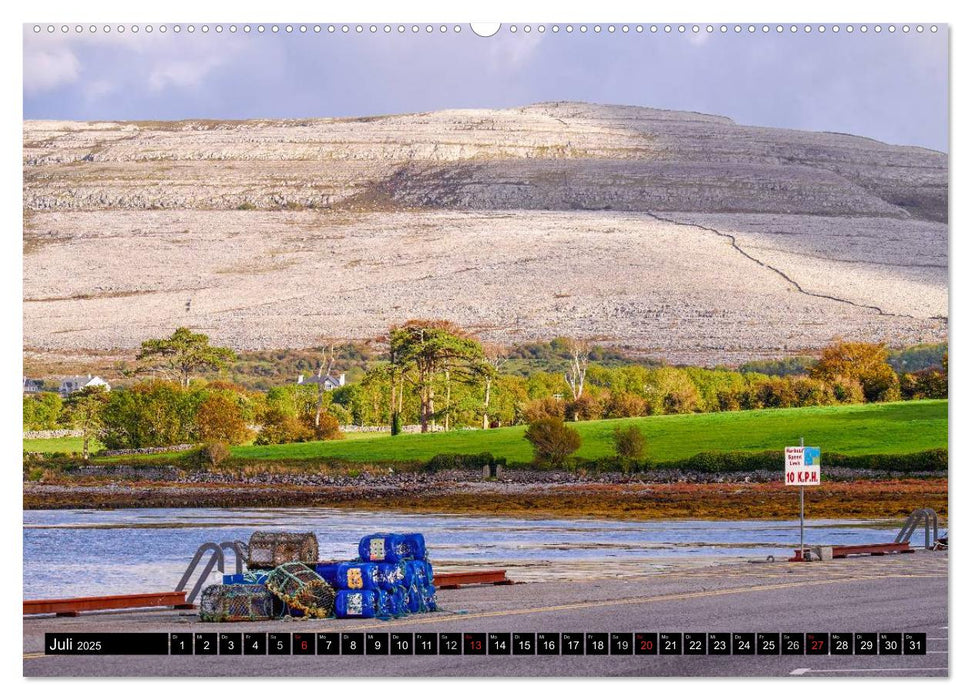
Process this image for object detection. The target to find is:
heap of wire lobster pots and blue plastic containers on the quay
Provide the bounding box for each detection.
[199,532,437,622]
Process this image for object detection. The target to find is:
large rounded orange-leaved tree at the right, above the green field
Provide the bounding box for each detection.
[810,340,900,401]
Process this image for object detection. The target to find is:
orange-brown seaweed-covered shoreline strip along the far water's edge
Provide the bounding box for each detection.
[23,478,948,520]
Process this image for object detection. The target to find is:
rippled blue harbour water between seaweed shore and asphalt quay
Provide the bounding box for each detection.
[24,508,899,598]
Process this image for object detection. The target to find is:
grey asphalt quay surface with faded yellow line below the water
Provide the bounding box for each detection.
[24,551,948,677]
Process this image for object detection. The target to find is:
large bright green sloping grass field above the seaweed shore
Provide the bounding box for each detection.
[232,401,947,462]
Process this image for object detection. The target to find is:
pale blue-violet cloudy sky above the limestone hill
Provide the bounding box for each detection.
[24,25,949,151]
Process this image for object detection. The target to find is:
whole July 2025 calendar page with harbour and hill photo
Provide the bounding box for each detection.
[19,13,950,678]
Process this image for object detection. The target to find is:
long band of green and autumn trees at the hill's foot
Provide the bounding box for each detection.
[23,320,947,452]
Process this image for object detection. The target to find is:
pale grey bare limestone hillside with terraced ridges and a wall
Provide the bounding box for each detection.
[24,103,948,363]
